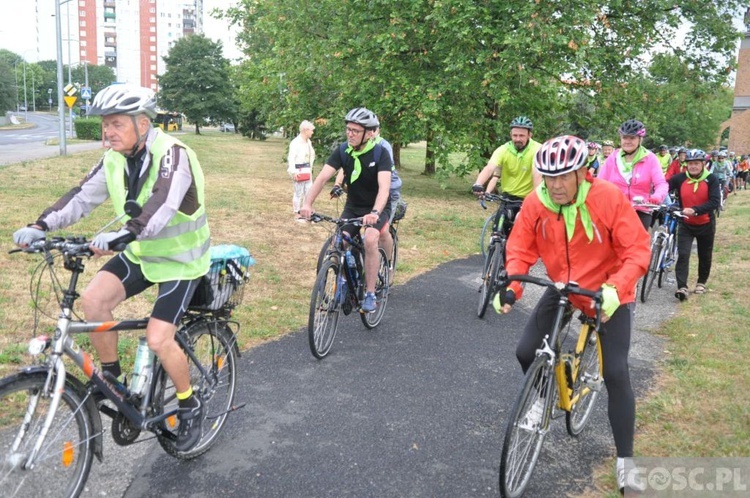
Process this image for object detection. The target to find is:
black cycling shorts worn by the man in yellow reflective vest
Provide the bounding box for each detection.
[99,253,200,325]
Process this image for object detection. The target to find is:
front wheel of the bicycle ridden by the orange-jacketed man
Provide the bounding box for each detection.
[499,355,556,498]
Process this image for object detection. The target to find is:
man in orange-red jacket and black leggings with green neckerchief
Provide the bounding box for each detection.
[494,136,651,490]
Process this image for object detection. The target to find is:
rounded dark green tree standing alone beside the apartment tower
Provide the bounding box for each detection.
[158,35,236,134]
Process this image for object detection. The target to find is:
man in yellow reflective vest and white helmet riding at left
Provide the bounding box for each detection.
[13,84,210,452]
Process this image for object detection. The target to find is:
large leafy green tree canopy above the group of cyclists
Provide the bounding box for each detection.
[228,0,744,173]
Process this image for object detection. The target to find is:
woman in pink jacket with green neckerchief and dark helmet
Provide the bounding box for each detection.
[597,119,668,230]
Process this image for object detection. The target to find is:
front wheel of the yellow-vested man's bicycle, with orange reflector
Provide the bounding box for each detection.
[0,372,96,497]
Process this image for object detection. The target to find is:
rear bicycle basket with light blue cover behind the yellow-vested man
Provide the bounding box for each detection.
[188,244,255,311]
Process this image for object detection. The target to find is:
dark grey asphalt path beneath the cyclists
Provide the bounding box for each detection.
[110,256,674,498]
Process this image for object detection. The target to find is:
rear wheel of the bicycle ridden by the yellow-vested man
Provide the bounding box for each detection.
[156,320,237,460]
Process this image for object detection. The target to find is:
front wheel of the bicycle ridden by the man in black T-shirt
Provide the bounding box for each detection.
[307,258,340,360]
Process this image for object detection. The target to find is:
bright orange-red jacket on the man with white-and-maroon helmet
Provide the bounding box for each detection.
[506,175,651,316]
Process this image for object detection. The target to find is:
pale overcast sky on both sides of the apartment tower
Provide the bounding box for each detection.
[0,0,242,63]
